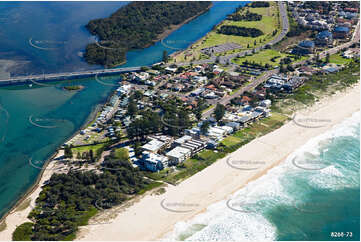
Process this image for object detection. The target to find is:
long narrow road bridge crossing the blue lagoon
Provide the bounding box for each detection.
[0,67,141,86]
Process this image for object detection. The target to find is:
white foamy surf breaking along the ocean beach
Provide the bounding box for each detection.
[166,112,360,241]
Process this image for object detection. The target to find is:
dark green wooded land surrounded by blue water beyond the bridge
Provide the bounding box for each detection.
[84,1,211,67]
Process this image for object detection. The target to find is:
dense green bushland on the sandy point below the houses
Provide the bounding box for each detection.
[13,151,159,240]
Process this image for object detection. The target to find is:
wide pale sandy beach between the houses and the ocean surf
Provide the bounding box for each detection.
[77,84,360,240]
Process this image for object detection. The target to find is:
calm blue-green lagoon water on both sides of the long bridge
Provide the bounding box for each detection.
[0,2,245,220]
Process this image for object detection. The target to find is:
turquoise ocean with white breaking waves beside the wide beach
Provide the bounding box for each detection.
[166,112,360,241]
